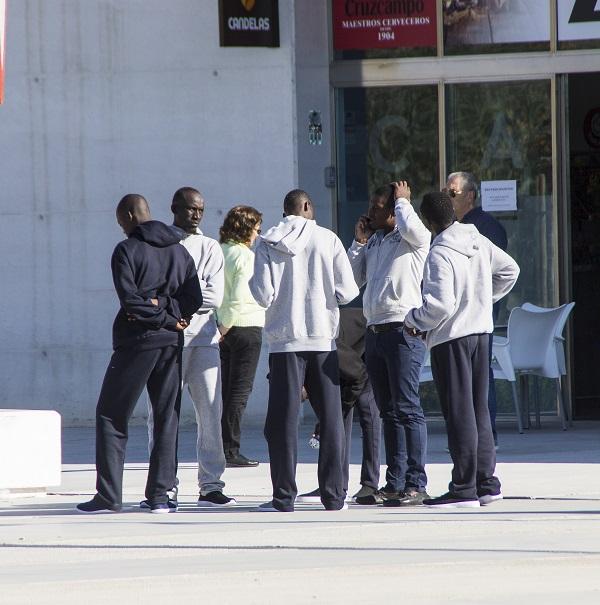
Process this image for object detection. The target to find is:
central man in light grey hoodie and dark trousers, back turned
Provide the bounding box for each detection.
[249,189,358,512]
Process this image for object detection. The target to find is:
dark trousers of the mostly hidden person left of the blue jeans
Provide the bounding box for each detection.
[343,380,381,489]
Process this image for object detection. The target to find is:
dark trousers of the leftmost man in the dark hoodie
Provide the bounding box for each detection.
[96,346,181,506]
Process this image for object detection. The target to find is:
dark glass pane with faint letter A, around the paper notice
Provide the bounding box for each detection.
[446,80,558,324]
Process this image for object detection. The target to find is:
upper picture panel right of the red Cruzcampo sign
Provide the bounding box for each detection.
[443,0,550,55]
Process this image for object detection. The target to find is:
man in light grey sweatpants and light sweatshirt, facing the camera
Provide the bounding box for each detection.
[142,187,236,507]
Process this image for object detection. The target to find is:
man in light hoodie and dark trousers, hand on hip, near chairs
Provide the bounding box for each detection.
[404,192,519,508]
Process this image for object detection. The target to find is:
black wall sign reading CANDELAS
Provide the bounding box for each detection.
[219,0,279,46]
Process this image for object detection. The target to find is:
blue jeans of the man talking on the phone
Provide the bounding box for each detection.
[365,328,427,491]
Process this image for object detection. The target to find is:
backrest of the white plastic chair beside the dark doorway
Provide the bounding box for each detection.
[508,307,566,378]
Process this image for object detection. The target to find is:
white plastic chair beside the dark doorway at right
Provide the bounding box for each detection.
[493,303,574,430]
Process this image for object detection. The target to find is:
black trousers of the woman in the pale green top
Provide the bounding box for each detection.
[219,326,262,459]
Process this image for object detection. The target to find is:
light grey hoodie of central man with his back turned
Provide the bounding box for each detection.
[249,216,358,353]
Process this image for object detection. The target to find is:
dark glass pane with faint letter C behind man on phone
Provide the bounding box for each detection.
[337,85,439,246]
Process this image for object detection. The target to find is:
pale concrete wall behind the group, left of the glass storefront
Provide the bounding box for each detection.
[0,0,300,425]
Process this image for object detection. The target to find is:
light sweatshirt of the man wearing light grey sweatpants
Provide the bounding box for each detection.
[181,229,224,347]
